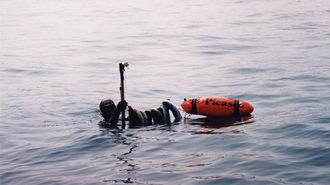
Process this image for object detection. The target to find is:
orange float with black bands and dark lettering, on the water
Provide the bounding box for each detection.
[181,96,253,117]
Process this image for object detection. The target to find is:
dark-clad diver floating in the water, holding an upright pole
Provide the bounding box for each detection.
[100,99,182,128]
